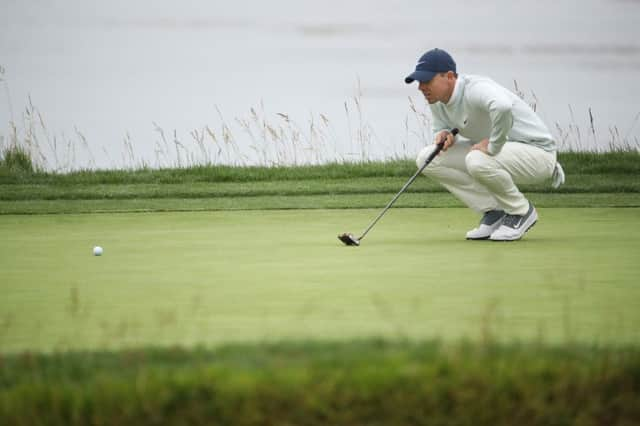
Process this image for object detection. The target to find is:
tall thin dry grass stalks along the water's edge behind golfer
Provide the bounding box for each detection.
[0,67,640,173]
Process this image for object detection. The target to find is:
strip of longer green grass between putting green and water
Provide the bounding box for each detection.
[0,151,640,214]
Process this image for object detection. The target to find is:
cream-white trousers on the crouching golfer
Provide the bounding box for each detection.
[416,140,556,215]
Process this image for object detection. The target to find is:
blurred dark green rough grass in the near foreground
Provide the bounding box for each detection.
[0,340,640,426]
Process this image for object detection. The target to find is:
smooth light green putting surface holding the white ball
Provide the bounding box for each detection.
[0,208,640,352]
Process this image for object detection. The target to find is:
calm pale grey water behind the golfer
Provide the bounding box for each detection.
[0,0,640,168]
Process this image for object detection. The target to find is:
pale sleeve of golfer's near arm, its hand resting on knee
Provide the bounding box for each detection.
[468,83,513,155]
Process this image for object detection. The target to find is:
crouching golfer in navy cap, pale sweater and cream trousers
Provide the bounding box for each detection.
[405,49,564,241]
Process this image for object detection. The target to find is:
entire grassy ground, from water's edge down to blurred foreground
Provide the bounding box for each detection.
[0,152,640,425]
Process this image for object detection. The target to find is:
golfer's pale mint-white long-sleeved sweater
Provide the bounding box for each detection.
[429,74,557,155]
